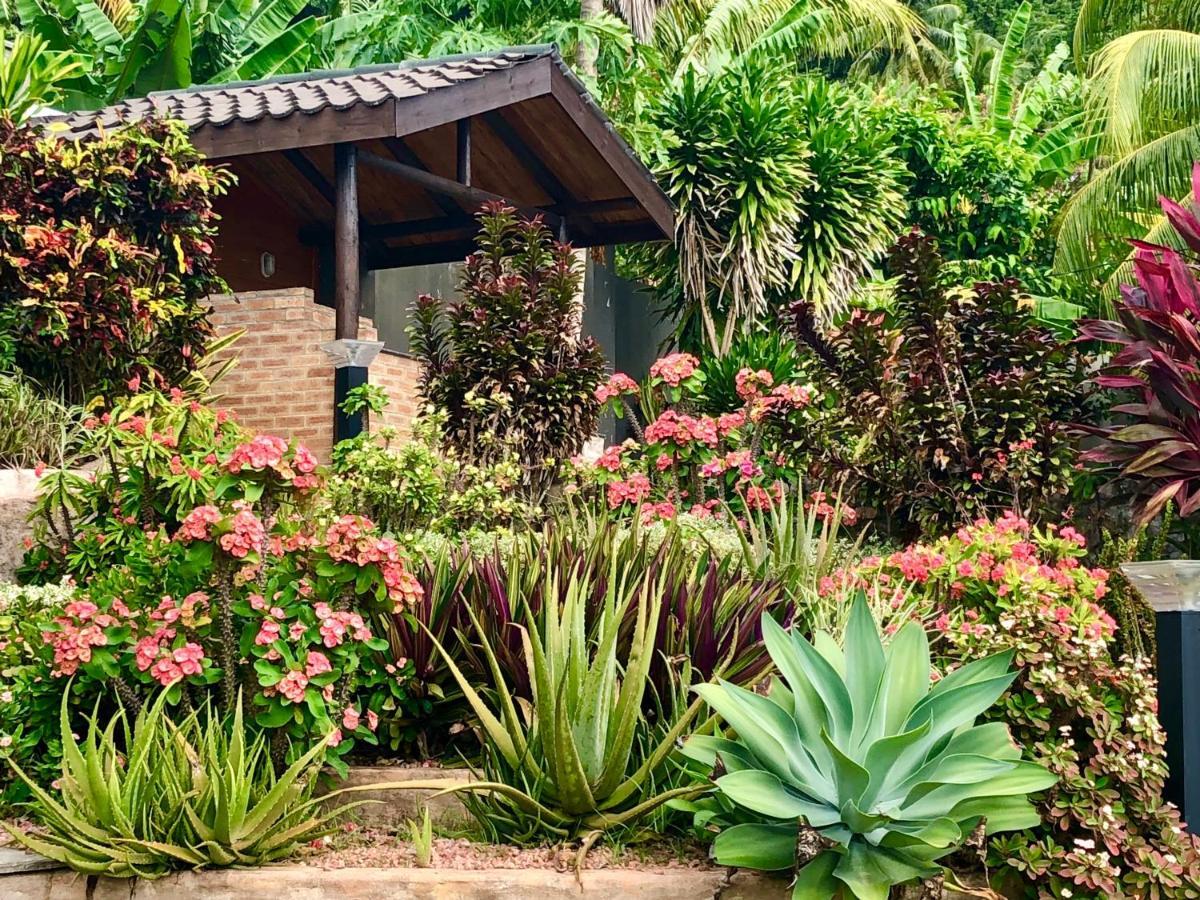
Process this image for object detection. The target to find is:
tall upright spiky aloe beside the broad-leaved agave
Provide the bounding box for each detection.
[372,559,707,857]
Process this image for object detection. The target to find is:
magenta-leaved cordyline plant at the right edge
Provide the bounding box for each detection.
[1080,163,1200,521]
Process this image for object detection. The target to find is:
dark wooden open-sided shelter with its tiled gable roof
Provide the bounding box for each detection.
[44,46,673,338]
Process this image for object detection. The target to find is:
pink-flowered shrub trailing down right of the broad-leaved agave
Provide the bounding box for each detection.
[847,515,1200,900]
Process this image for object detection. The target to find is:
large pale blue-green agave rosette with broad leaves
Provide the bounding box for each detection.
[684,596,1056,900]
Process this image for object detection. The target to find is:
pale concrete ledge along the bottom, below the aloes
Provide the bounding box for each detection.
[0,865,790,900]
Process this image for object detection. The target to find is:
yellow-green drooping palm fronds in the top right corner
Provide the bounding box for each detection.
[1056,0,1200,289]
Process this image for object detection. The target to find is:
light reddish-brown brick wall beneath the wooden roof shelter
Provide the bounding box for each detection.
[210,288,420,460]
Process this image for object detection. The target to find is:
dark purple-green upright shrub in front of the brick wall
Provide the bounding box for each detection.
[409,203,604,504]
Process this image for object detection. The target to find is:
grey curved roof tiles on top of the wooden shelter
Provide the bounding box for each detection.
[42,44,557,137]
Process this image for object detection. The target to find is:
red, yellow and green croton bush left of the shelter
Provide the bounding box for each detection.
[0,118,230,402]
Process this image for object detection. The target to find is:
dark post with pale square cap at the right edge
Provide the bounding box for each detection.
[1121,559,1200,833]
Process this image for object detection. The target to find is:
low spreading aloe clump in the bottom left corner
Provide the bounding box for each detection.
[4,691,355,878]
